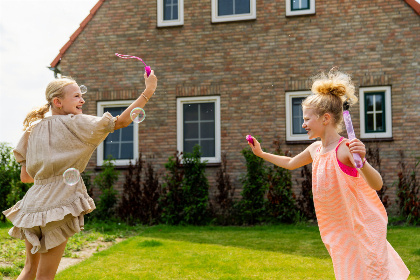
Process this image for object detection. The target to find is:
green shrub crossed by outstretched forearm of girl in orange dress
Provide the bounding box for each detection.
[266,139,298,223]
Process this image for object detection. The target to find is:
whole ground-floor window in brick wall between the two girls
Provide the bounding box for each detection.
[177,96,221,163]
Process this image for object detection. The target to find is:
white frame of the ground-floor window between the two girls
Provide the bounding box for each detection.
[176,96,221,163]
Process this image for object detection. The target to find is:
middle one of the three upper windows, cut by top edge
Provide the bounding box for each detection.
[211,0,257,22]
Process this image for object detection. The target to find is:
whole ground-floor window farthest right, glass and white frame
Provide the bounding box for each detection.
[359,87,392,138]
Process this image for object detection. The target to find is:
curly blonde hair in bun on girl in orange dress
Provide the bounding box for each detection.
[302,68,357,129]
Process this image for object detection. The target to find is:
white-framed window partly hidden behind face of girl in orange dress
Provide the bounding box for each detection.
[286,91,311,141]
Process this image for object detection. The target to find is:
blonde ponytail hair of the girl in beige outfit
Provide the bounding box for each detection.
[23,77,76,130]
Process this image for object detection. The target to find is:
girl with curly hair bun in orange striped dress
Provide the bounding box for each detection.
[248,69,410,280]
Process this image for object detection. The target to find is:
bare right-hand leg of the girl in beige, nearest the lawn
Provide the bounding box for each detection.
[36,239,68,280]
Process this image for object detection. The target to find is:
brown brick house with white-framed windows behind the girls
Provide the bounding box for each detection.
[51,0,420,212]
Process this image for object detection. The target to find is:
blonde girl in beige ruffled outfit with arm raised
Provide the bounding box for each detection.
[3,71,157,280]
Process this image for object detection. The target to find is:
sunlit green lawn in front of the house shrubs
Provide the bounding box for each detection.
[0,222,420,280]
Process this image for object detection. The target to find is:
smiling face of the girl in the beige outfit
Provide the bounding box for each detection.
[54,84,85,115]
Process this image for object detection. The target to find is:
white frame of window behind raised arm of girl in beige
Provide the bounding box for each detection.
[96,100,139,166]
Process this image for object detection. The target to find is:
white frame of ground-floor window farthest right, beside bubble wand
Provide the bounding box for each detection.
[359,86,392,139]
